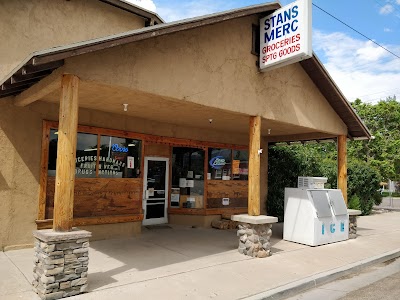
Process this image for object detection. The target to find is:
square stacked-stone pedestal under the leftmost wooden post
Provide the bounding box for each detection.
[32,228,92,300]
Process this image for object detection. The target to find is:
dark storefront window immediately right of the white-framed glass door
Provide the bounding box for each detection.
[171,147,205,208]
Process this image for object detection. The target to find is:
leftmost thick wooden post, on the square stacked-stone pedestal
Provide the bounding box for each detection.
[53,74,79,231]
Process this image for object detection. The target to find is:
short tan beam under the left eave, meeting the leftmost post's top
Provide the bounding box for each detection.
[14,69,62,106]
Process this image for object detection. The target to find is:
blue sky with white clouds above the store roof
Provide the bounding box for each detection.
[125,0,400,103]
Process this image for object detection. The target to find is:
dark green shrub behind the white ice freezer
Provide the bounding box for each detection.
[267,146,382,222]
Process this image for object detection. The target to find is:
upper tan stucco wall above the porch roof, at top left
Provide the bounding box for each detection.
[0,0,144,80]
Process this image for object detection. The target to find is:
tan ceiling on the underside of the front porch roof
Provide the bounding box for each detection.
[40,81,330,142]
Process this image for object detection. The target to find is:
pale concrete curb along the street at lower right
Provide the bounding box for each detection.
[241,249,400,300]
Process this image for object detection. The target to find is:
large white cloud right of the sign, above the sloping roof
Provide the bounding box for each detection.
[313,30,400,102]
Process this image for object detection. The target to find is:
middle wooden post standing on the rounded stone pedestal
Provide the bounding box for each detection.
[247,116,261,216]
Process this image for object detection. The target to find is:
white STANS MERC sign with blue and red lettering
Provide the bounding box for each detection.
[260,0,312,71]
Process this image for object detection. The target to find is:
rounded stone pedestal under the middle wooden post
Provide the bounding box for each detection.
[232,215,278,258]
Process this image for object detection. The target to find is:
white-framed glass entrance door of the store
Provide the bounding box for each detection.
[143,157,169,225]
